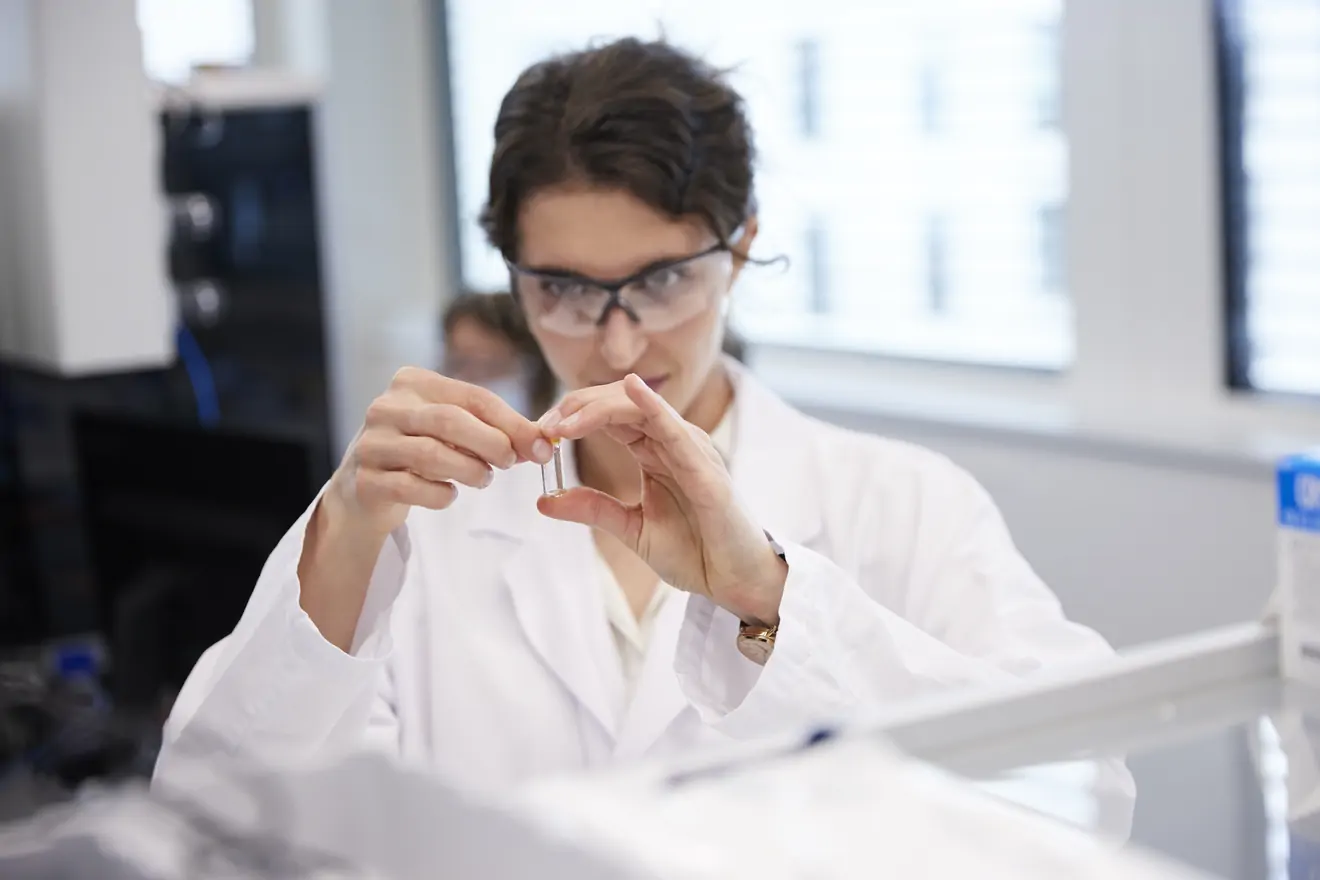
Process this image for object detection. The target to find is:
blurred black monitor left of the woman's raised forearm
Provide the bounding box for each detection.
[74,412,323,707]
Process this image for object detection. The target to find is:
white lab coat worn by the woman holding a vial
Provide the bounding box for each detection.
[156,372,1110,792]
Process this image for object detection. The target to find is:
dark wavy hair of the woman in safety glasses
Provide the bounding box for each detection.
[480,38,755,261]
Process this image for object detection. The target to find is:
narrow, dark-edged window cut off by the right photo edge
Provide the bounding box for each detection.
[1218,0,1320,393]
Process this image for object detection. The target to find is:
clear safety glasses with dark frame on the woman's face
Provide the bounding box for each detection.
[508,244,733,336]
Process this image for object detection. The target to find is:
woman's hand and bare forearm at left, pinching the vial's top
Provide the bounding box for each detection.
[298,368,553,652]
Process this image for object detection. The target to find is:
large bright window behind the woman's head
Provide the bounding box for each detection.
[445,0,1073,369]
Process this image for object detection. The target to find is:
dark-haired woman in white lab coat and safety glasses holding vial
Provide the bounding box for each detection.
[157,40,1109,790]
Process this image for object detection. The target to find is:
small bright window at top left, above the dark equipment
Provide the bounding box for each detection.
[137,0,253,83]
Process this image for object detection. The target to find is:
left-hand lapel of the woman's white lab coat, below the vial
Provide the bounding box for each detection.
[474,450,623,740]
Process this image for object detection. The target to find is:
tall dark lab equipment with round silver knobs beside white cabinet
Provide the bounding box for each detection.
[161,104,331,476]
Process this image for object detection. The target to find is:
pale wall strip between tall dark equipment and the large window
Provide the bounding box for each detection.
[311,0,451,447]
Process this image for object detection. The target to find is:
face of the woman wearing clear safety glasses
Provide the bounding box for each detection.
[519,185,754,413]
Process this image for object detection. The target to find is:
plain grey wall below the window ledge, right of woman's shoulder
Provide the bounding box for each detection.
[833,413,1274,645]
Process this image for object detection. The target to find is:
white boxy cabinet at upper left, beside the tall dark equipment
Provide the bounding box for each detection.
[0,0,174,375]
